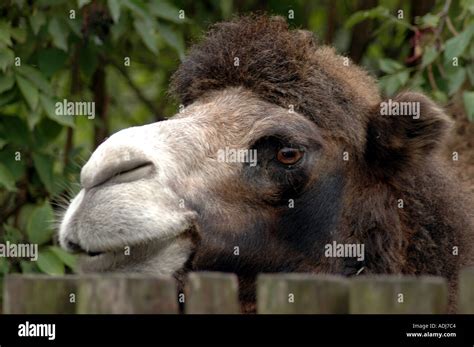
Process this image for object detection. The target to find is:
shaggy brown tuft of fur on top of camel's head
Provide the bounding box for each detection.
[171,16,379,151]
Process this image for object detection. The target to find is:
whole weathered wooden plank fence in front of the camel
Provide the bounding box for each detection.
[3,267,474,314]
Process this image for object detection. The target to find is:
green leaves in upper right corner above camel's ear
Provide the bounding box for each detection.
[346,1,474,110]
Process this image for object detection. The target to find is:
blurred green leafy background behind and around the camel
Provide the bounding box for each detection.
[0,0,474,295]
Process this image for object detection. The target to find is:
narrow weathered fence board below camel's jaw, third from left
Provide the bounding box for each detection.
[184,272,240,314]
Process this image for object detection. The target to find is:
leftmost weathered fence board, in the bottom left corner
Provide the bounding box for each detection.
[3,274,77,314]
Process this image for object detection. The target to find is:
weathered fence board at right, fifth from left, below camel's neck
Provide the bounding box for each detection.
[349,275,448,314]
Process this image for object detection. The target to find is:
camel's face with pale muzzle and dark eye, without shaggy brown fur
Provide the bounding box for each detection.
[60,88,331,274]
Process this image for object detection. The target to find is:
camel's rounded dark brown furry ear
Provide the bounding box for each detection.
[365,92,451,175]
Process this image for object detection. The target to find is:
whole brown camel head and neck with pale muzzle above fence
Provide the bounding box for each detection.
[60,16,474,312]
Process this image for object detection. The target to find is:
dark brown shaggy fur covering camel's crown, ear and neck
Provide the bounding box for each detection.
[172,16,474,310]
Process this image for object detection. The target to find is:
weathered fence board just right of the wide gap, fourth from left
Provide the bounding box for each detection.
[257,273,349,314]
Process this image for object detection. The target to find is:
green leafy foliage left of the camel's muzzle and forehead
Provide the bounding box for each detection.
[0,0,190,277]
